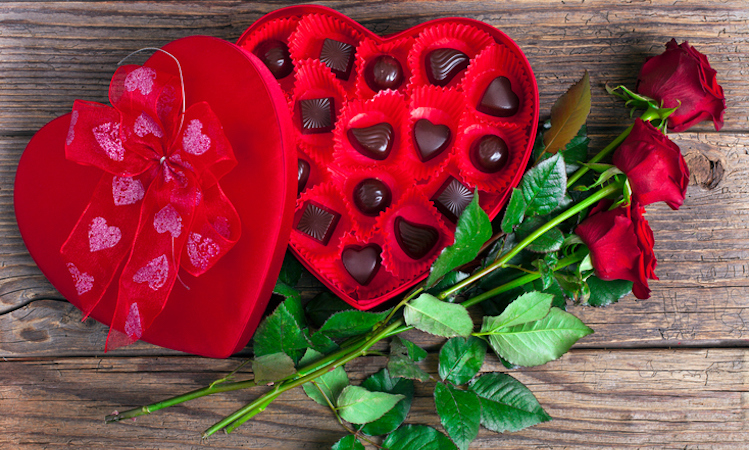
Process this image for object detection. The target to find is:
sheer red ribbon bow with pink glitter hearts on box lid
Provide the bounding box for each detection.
[60,65,241,350]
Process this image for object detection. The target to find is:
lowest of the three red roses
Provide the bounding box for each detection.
[575,200,658,299]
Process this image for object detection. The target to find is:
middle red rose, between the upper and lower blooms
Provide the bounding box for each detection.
[613,119,689,209]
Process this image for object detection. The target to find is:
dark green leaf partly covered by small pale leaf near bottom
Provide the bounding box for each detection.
[360,369,414,436]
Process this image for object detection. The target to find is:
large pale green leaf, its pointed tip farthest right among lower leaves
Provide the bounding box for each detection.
[482,308,593,366]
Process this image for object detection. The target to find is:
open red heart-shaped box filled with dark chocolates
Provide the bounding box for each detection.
[238,6,538,309]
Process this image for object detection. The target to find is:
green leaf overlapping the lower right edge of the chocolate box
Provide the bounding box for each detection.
[426,190,492,286]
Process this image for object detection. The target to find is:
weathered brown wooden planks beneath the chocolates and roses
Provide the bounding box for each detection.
[0,0,749,449]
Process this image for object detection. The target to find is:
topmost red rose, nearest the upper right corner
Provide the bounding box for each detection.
[637,39,726,132]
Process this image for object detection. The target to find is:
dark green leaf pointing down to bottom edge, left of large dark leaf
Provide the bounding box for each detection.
[434,383,481,450]
